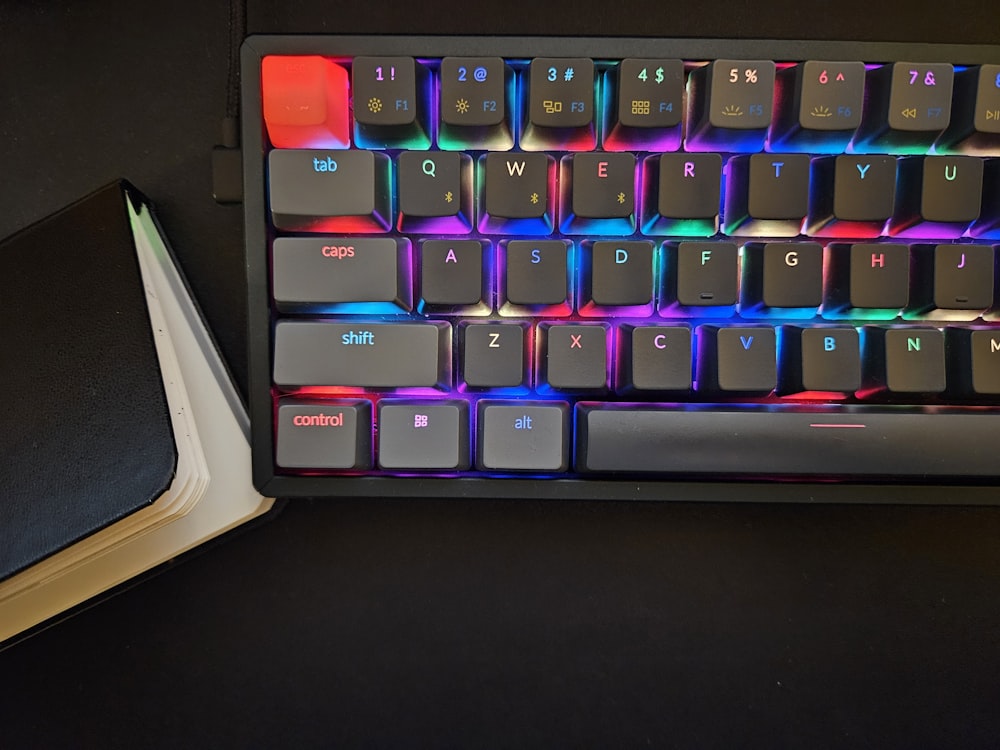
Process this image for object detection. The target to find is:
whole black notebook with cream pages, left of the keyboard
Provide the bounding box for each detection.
[0,181,273,642]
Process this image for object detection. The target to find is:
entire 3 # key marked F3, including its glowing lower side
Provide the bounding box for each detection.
[521,57,596,151]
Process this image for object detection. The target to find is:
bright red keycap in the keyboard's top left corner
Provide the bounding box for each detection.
[260,55,351,148]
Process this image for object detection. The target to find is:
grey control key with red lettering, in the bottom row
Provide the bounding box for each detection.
[275,398,372,469]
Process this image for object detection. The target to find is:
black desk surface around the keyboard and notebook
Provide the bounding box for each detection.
[0,0,1000,748]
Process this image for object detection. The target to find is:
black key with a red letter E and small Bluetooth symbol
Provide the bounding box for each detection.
[561,153,635,234]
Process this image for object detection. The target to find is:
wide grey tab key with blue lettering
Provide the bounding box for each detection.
[268,149,392,232]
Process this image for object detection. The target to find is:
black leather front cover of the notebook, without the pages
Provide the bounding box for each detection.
[0,183,177,580]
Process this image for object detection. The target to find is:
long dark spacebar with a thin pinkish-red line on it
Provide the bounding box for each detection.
[576,404,1000,478]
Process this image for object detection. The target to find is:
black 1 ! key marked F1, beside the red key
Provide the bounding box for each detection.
[351,56,430,149]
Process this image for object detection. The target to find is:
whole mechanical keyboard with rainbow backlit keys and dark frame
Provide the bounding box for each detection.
[242,36,1000,503]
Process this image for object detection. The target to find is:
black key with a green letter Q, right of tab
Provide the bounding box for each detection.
[397,151,472,234]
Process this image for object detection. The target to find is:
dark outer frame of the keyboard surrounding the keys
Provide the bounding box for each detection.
[241,35,1000,505]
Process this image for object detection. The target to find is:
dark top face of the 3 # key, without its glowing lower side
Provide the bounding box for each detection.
[528,57,594,128]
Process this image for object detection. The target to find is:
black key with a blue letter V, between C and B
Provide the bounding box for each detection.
[696,326,778,395]
